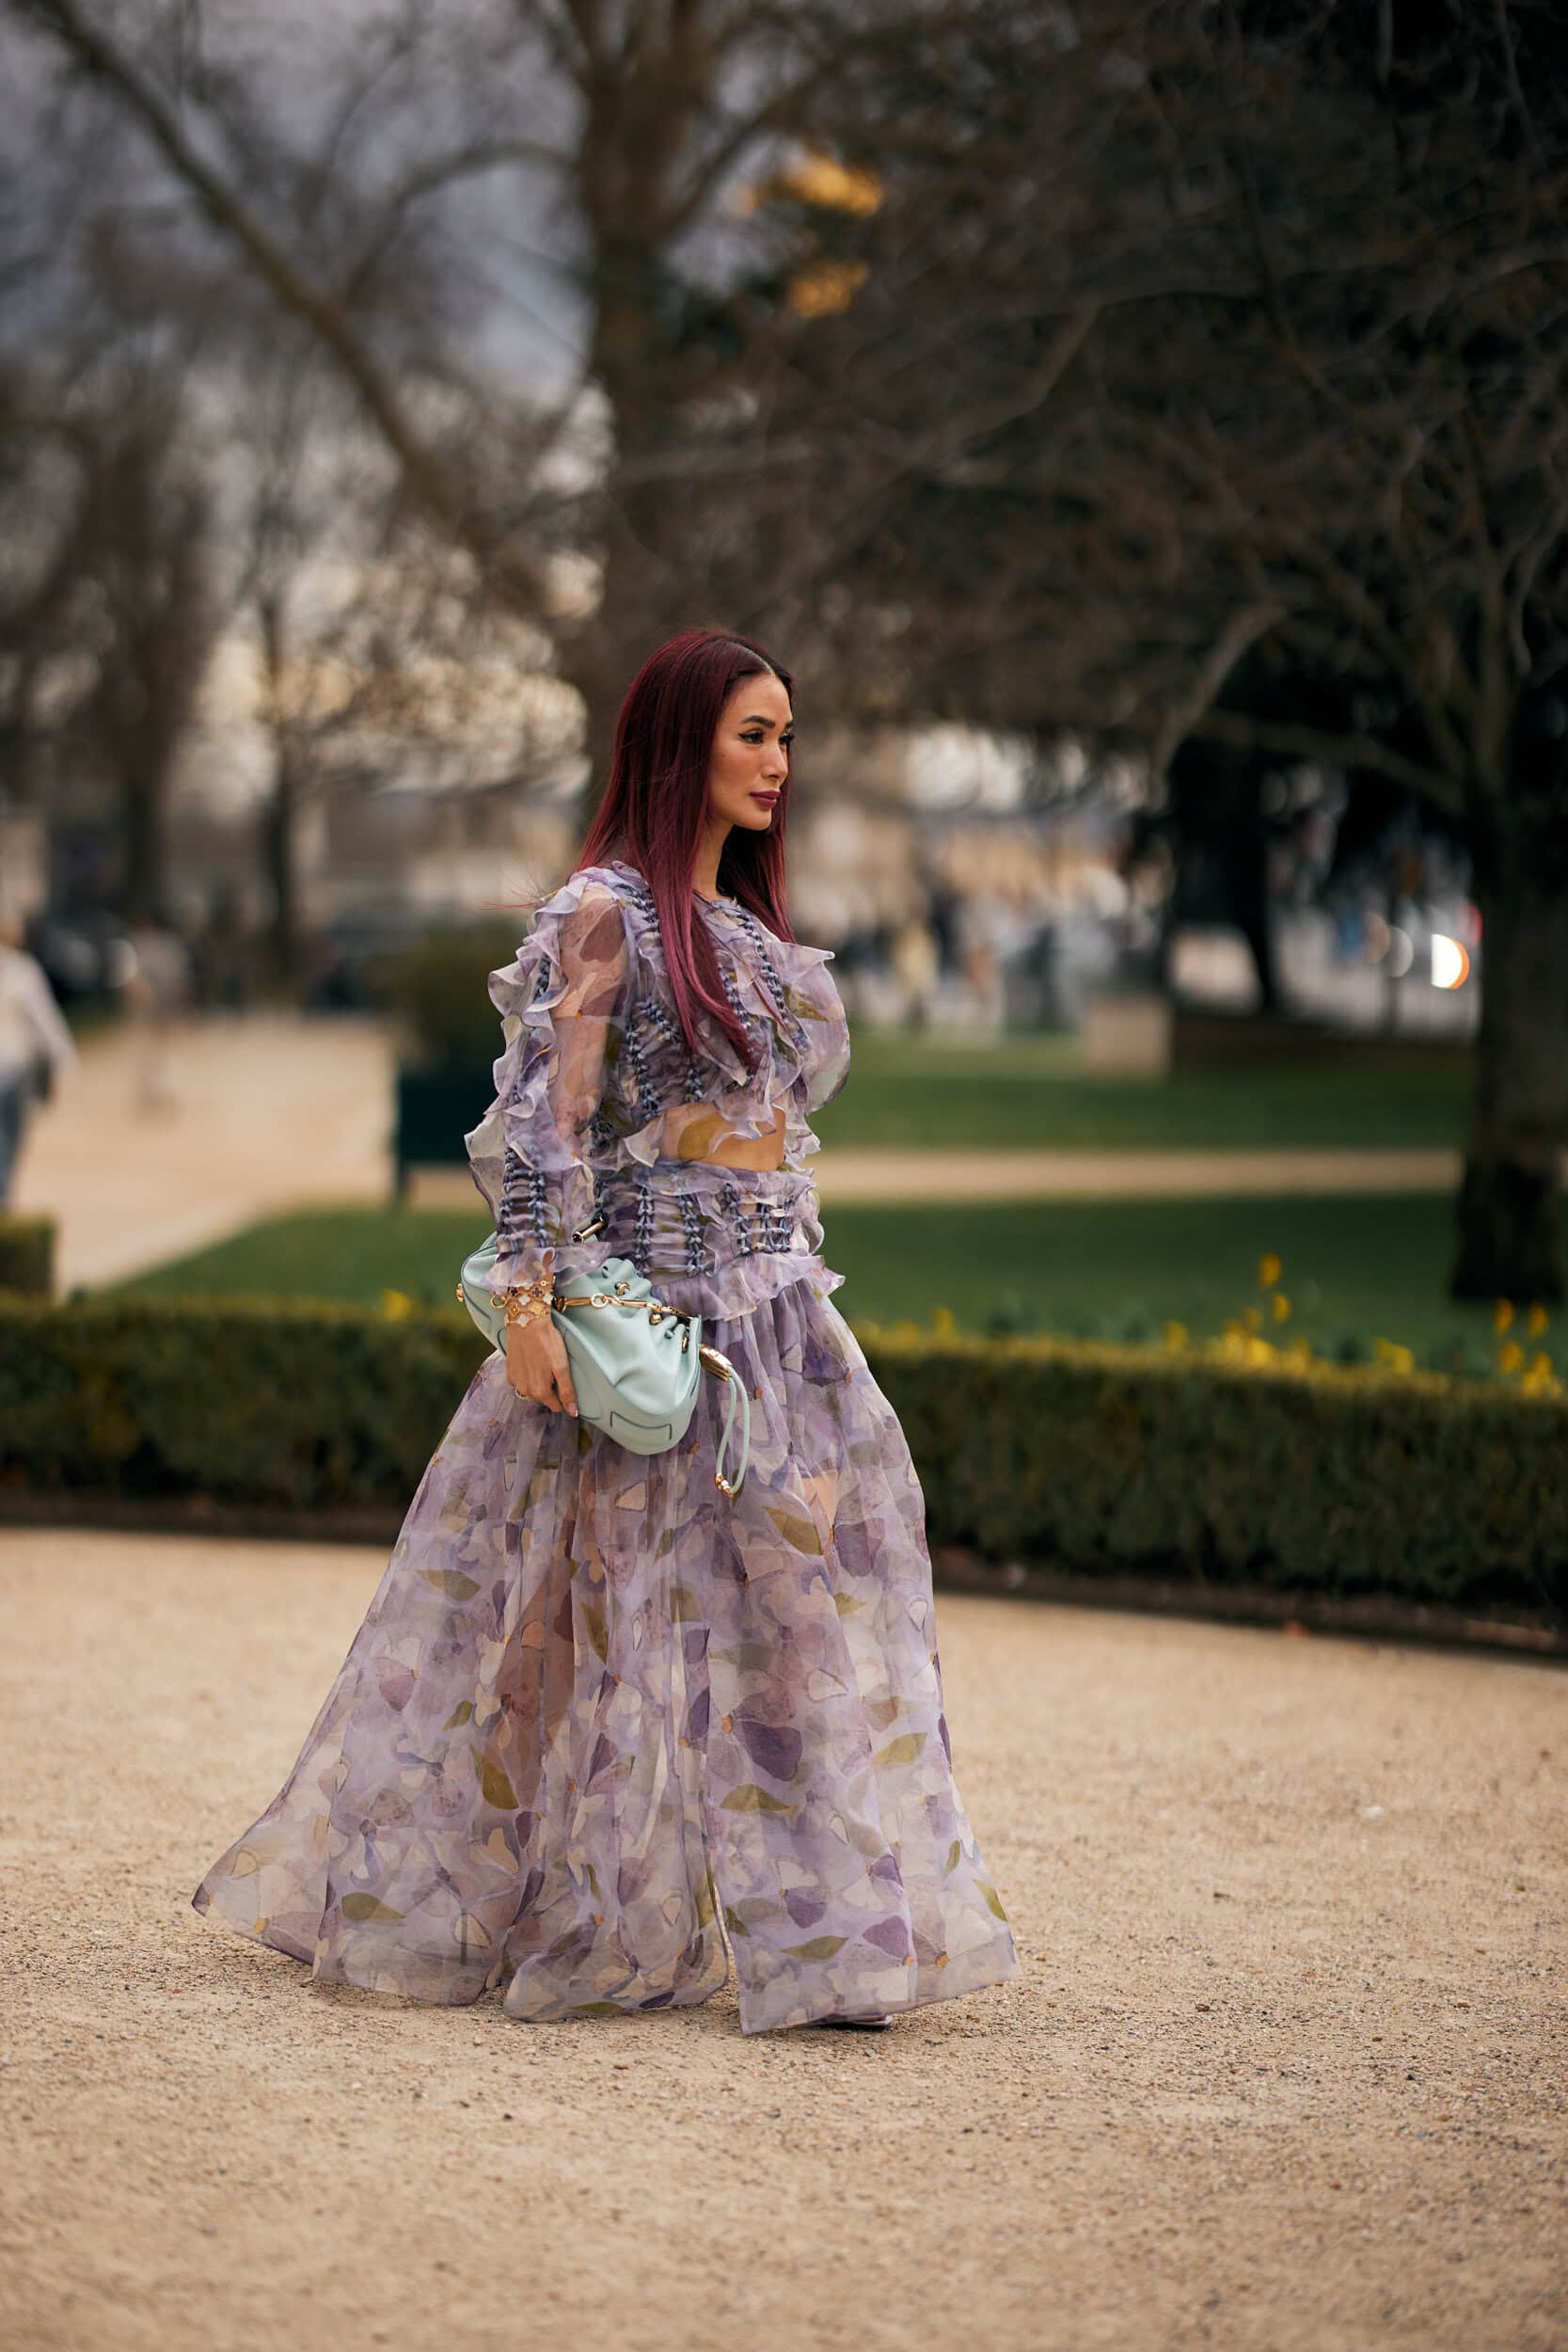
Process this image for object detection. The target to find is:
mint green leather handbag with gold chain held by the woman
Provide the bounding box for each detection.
[458,1218,752,1496]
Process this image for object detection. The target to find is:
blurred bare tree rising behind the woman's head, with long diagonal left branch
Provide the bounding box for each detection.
[7,0,983,770]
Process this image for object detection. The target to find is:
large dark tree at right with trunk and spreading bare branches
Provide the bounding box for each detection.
[766,0,1568,1298]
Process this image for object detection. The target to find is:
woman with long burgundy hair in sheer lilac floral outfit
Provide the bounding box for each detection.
[193,630,1018,2032]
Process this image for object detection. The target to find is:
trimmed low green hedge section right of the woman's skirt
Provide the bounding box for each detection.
[858,1331,1568,1626]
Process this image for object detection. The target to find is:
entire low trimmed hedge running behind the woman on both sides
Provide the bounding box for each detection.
[0,1296,1568,1623]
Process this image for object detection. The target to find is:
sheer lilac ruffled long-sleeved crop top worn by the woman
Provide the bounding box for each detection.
[463,859,848,1312]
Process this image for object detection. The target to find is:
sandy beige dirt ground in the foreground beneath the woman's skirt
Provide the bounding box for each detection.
[0,1529,1568,2352]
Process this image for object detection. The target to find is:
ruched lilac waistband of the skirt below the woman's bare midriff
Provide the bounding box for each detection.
[557,1160,844,1317]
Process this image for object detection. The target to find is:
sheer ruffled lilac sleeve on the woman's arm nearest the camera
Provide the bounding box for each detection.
[466,878,630,1287]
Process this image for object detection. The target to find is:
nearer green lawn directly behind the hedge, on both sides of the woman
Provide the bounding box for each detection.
[118,1193,1554,1369]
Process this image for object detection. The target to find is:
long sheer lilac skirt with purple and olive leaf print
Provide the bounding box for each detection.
[193,1176,1018,2032]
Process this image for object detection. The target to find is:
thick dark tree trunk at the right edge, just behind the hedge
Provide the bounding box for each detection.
[1449,818,1568,1303]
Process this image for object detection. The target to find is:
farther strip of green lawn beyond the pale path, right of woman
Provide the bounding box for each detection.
[814,1030,1469,1151]
